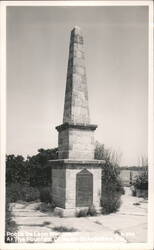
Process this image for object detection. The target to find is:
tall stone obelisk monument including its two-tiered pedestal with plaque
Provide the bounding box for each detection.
[50,27,104,216]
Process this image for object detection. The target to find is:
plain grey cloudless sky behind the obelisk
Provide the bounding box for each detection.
[7,6,148,166]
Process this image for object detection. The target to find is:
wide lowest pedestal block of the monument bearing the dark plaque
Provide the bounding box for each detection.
[49,159,104,217]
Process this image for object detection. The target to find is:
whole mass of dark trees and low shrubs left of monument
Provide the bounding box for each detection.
[6,148,57,202]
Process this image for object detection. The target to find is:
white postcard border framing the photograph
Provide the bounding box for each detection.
[0,0,154,249]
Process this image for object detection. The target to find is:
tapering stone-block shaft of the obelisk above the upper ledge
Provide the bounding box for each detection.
[63,27,90,124]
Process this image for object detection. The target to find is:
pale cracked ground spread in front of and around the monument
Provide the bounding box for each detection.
[8,188,147,243]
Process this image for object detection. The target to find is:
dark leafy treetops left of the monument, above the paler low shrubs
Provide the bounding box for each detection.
[6,148,58,186]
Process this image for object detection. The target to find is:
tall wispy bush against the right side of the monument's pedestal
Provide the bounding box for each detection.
[95,143,124,214]
